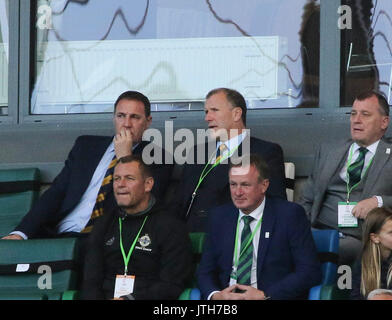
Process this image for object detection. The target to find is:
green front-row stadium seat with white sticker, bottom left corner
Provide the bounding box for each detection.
[0,238,78,300]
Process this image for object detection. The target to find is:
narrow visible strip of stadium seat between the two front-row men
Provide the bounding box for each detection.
[178,232,205,300]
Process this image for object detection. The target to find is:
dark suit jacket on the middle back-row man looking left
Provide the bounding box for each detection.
[172,136,286,232]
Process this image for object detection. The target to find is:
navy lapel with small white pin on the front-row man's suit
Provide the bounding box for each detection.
[257,198,276,279]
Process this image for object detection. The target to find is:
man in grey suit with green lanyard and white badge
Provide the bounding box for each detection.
[300,91,392,265]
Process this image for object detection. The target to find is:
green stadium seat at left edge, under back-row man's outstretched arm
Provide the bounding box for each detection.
[0,168,40,237]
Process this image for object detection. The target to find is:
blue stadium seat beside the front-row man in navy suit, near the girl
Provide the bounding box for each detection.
[308,229,339,300]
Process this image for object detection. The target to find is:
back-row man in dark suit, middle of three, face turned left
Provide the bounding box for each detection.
[172,88,286,232]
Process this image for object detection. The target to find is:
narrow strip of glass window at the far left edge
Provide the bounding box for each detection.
[0,0,9,116]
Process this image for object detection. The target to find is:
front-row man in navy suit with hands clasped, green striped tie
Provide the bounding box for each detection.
[198,154,321,300]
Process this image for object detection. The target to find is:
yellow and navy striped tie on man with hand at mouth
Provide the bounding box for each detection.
[81,156,117,233]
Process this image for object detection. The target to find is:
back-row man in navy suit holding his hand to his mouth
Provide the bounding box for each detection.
[5,91,172,240]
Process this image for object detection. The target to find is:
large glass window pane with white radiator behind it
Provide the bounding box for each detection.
[31,0,320,114]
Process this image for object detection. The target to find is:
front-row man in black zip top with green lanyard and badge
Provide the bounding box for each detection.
[82,155,192,300]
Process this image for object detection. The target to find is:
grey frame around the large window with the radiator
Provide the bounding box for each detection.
[13,0,347,125]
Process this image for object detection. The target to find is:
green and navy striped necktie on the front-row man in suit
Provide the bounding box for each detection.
[237,216,253,285]
